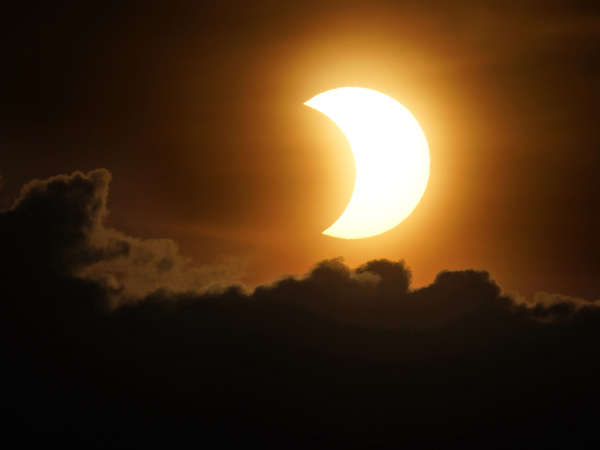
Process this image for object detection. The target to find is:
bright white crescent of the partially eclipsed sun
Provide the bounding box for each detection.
[304,87,429,239]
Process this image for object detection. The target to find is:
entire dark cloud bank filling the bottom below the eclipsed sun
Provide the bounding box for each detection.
[0,169,600,448]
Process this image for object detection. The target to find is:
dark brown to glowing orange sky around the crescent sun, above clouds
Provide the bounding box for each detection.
[0,1,600,299]
